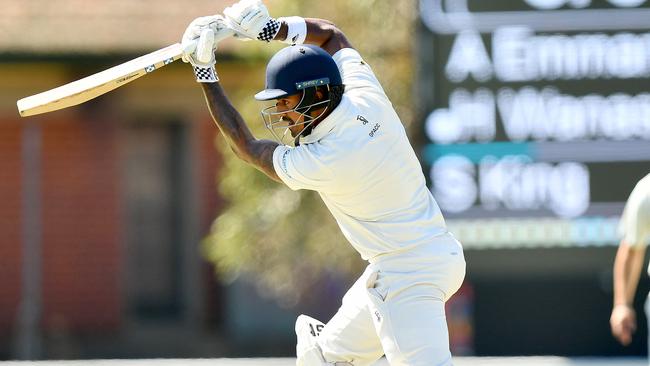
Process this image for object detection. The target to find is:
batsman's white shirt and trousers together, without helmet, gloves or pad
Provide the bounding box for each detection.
[273,48,465,366]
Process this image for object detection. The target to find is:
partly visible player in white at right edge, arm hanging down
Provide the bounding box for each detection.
[609,174,650,346]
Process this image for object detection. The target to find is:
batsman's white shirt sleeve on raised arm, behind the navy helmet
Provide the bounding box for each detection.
[332,48,385,95]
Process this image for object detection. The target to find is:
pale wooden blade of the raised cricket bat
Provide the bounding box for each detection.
[16,43,183,117]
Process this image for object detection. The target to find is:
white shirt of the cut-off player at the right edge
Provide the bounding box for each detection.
[619,174,650,250]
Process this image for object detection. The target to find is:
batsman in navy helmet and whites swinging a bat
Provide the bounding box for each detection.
[183,0,465,366]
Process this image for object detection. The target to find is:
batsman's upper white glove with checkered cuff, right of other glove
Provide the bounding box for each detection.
[223,0,280,42]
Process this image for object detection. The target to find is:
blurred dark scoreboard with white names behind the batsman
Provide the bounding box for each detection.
[416,0,650,248]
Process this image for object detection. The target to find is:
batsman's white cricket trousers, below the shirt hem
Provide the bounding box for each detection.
[318,234,465,366]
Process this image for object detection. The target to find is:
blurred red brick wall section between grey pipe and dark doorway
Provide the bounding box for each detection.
[42,119,121,331]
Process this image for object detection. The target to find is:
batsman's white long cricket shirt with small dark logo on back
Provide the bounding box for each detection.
[273,48,447,260]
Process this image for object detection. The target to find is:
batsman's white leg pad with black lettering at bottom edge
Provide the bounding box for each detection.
[296,315,353,366]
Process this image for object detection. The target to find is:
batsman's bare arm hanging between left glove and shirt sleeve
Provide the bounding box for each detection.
[201,83,282,182]
